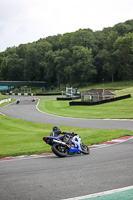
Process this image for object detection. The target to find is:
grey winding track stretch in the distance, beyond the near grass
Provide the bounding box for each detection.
[0,96,133,130]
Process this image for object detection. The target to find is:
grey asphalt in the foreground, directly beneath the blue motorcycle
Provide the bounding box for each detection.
[0,140,133,200]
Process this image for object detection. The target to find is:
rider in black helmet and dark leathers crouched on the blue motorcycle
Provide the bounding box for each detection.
[50,126,75,143]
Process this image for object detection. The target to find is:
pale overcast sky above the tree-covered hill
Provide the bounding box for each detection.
[0,0,133,52]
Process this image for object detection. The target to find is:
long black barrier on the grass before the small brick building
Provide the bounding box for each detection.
[69,94,131,106]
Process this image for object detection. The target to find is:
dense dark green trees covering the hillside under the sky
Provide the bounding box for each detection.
[0,20,133,86]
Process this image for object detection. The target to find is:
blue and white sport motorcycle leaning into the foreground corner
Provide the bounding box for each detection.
[43,134,90,157]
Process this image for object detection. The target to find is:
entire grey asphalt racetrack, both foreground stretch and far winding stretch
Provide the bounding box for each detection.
[0,97,133,200]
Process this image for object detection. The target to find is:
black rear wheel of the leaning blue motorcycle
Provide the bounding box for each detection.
[52,144,68,157]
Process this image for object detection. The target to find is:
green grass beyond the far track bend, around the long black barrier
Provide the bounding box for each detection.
[38,87,133,119]
